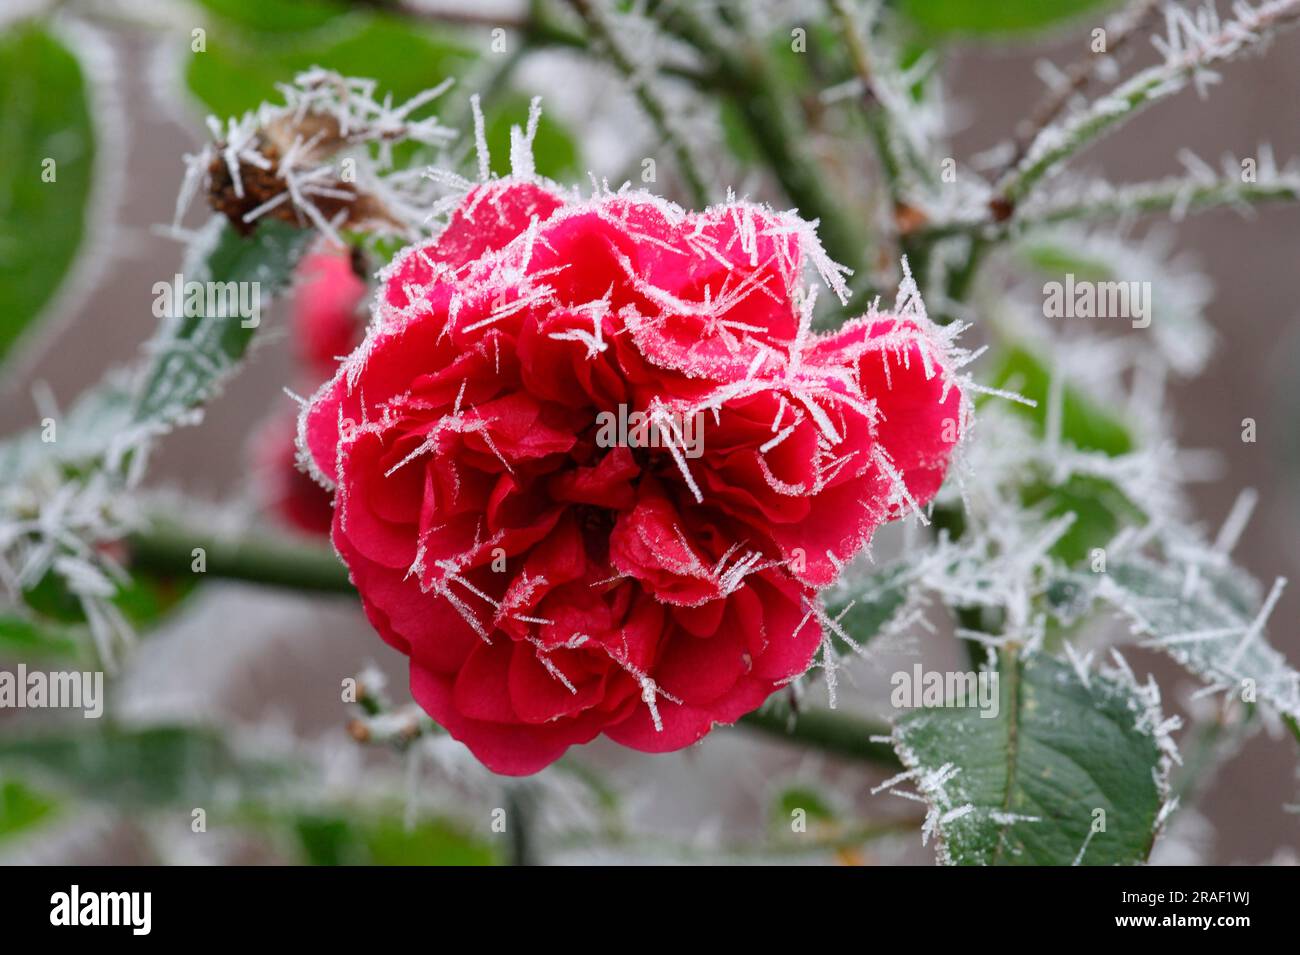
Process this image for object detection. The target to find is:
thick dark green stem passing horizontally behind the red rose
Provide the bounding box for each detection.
[126,521,901,768]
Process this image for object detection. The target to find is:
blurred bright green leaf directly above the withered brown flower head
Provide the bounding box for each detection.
[186,13,475,116]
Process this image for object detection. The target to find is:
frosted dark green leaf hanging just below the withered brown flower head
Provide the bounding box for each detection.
[134,220,316,424]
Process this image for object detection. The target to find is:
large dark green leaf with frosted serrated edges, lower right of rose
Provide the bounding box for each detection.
[894,654,1167,865]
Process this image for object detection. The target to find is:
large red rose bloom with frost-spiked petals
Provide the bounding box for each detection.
[299,179,963,774]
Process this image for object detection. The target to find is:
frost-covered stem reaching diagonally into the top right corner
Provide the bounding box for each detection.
[993,0,1300,209]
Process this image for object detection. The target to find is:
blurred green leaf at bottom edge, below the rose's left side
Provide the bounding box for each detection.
[294,815,498,865]
